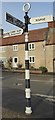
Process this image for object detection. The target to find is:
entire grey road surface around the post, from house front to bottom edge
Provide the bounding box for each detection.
[0,71,55,118]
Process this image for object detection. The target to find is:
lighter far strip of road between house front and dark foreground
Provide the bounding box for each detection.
[2,72,55,96]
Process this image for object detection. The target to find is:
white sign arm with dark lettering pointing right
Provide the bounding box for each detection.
[30,15,53,24]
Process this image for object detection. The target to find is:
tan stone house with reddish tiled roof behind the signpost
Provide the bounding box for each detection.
[0,21,55,72]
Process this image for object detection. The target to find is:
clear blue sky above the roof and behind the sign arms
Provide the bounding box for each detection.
[0,1,53,32]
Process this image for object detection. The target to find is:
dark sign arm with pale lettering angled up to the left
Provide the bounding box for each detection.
[6,12,25,29]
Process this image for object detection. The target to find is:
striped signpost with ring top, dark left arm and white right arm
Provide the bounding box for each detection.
[6,3,53,114]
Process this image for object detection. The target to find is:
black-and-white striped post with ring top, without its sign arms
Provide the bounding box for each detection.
[23,3,32,114]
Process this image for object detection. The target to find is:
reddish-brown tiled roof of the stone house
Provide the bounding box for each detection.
[0,28,55,46]
